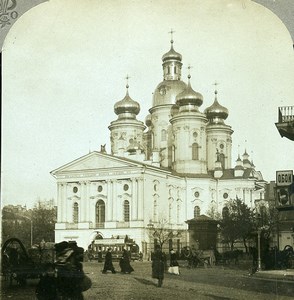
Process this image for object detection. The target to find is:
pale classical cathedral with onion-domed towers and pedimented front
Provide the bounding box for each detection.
[51,36,265,255]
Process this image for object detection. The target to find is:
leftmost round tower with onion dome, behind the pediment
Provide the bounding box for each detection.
[108,77,146,157]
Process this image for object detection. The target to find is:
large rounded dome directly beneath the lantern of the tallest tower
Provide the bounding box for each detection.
[152,80,187,107]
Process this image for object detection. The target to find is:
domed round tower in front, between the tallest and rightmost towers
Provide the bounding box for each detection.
[170,75,207,174]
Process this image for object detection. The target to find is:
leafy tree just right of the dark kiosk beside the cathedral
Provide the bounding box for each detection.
[221,198,255,252]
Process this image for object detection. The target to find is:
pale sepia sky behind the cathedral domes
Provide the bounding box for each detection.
[1,0,294,207]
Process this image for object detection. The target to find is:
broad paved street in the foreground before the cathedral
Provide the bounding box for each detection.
[1,261,294,300]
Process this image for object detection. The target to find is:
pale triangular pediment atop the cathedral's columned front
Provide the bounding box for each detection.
[51,152,142,175]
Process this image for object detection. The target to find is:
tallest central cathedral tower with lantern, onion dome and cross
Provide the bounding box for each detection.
[149,31,187,168]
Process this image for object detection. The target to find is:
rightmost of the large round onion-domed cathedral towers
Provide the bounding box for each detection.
[204,90,233,170]
